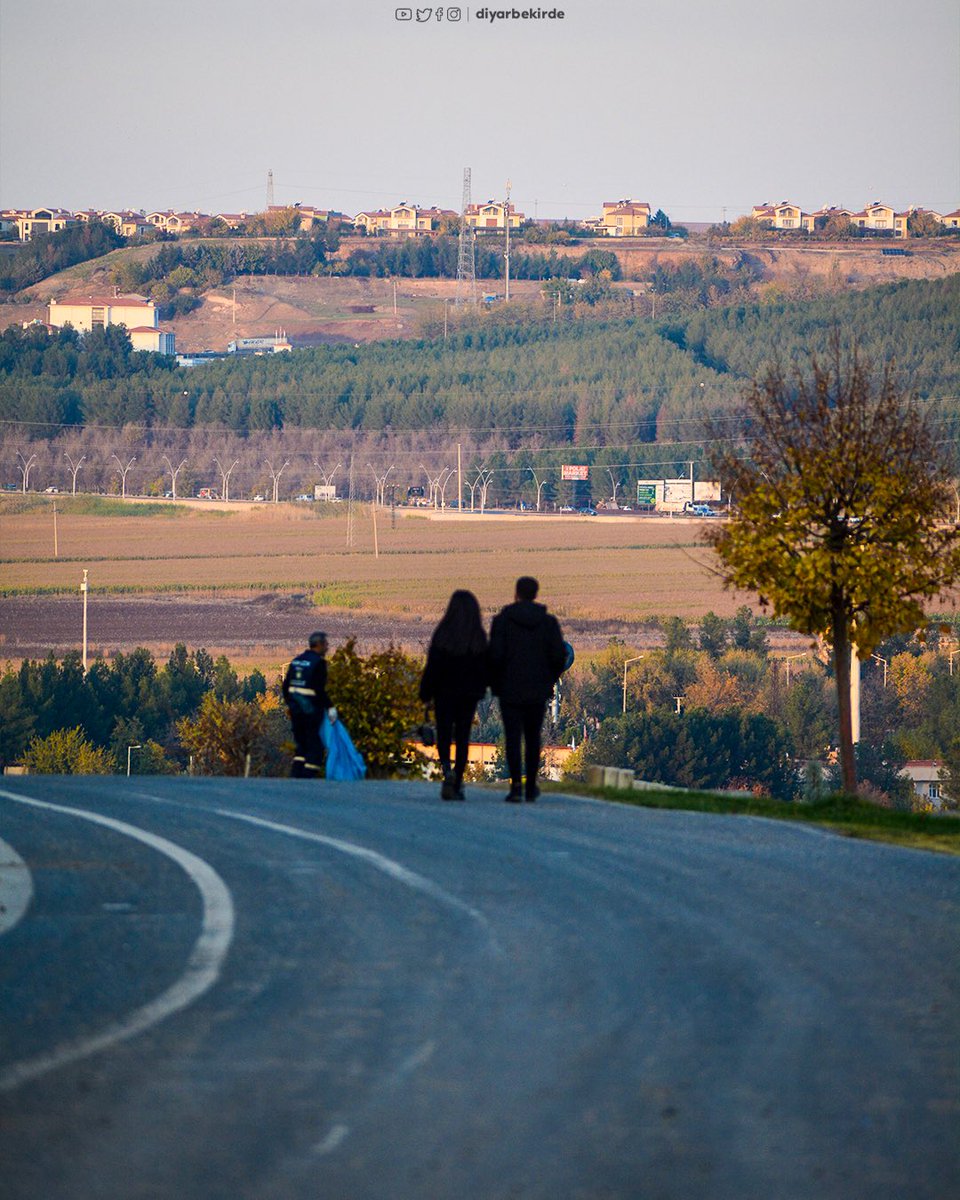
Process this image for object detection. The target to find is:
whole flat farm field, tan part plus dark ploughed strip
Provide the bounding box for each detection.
[0,497,768,660]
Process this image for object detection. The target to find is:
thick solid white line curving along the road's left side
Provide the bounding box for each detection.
[0,788,234,1092]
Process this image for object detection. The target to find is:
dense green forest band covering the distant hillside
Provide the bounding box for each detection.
[0,276,960,463]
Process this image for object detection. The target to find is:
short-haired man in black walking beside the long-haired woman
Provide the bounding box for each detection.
[490,575,566,804]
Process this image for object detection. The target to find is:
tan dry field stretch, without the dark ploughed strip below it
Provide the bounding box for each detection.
[0,504,750,622]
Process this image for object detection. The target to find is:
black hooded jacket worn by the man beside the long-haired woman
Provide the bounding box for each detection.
[490,600,566,704]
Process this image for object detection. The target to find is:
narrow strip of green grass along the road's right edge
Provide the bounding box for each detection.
[545,782,960,854]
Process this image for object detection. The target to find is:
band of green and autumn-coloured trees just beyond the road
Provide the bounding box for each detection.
[0,607,960,809]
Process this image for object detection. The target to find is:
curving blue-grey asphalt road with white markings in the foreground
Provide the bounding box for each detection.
[0,776,960,1200]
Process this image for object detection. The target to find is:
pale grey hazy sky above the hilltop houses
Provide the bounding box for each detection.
[0,0,960,222]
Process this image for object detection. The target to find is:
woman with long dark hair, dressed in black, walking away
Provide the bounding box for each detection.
[420,590,490,800]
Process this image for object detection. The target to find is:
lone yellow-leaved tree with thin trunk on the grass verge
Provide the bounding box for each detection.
[704,345,960,793]
